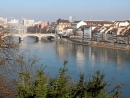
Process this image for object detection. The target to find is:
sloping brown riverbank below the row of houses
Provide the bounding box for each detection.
[56,38,130,51]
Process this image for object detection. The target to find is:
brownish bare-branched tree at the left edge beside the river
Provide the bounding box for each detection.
[0,26,18,98]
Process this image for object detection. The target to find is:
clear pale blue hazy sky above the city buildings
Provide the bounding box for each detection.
[0,0,130,22]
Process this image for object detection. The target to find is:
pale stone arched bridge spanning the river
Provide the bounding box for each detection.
[2,33,55,41]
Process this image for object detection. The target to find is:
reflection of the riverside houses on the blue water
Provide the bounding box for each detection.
[53,42,130,68]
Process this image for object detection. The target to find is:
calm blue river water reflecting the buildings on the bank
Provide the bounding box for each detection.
[17,37,130,98]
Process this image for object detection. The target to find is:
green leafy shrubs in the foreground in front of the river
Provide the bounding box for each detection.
[18,61,120,98]
